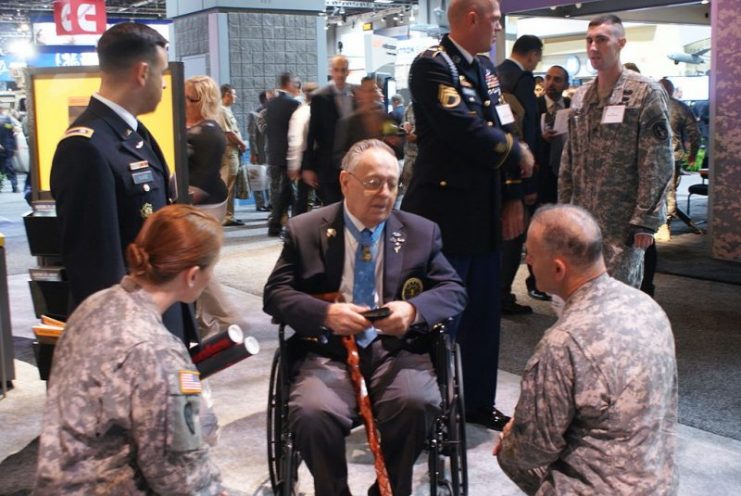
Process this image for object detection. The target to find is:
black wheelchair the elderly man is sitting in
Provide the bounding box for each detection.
[267,323,468,496]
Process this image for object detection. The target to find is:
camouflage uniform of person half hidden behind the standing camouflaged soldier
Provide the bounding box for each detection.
[666,98,702,220]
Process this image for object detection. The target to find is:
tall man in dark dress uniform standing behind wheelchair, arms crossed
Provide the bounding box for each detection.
[401,0,533,429]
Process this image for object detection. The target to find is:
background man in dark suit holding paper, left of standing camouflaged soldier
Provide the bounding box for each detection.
[525,65,571,301]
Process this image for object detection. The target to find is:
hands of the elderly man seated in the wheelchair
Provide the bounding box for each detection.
[324,301,417,337]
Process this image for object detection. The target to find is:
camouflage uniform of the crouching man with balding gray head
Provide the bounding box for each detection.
[499,274,677,496]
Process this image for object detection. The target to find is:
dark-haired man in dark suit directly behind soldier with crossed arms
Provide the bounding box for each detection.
[497,34,543,315]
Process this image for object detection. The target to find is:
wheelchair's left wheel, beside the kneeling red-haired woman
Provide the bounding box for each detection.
[267,350,301,496]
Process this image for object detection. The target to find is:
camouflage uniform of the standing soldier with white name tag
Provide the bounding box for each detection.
[558,70,674,287]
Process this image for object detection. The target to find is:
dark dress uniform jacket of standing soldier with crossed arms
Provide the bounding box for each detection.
[401,35,522,256]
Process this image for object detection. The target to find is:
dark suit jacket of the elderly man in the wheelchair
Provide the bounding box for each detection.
[263,202,466,355]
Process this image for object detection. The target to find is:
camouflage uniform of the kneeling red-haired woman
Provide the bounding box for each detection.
[35,277,222,495]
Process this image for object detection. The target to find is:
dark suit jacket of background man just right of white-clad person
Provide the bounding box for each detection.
[301,85,340,182]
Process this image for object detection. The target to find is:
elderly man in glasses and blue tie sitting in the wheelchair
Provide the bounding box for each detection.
[264,140,466,495]
